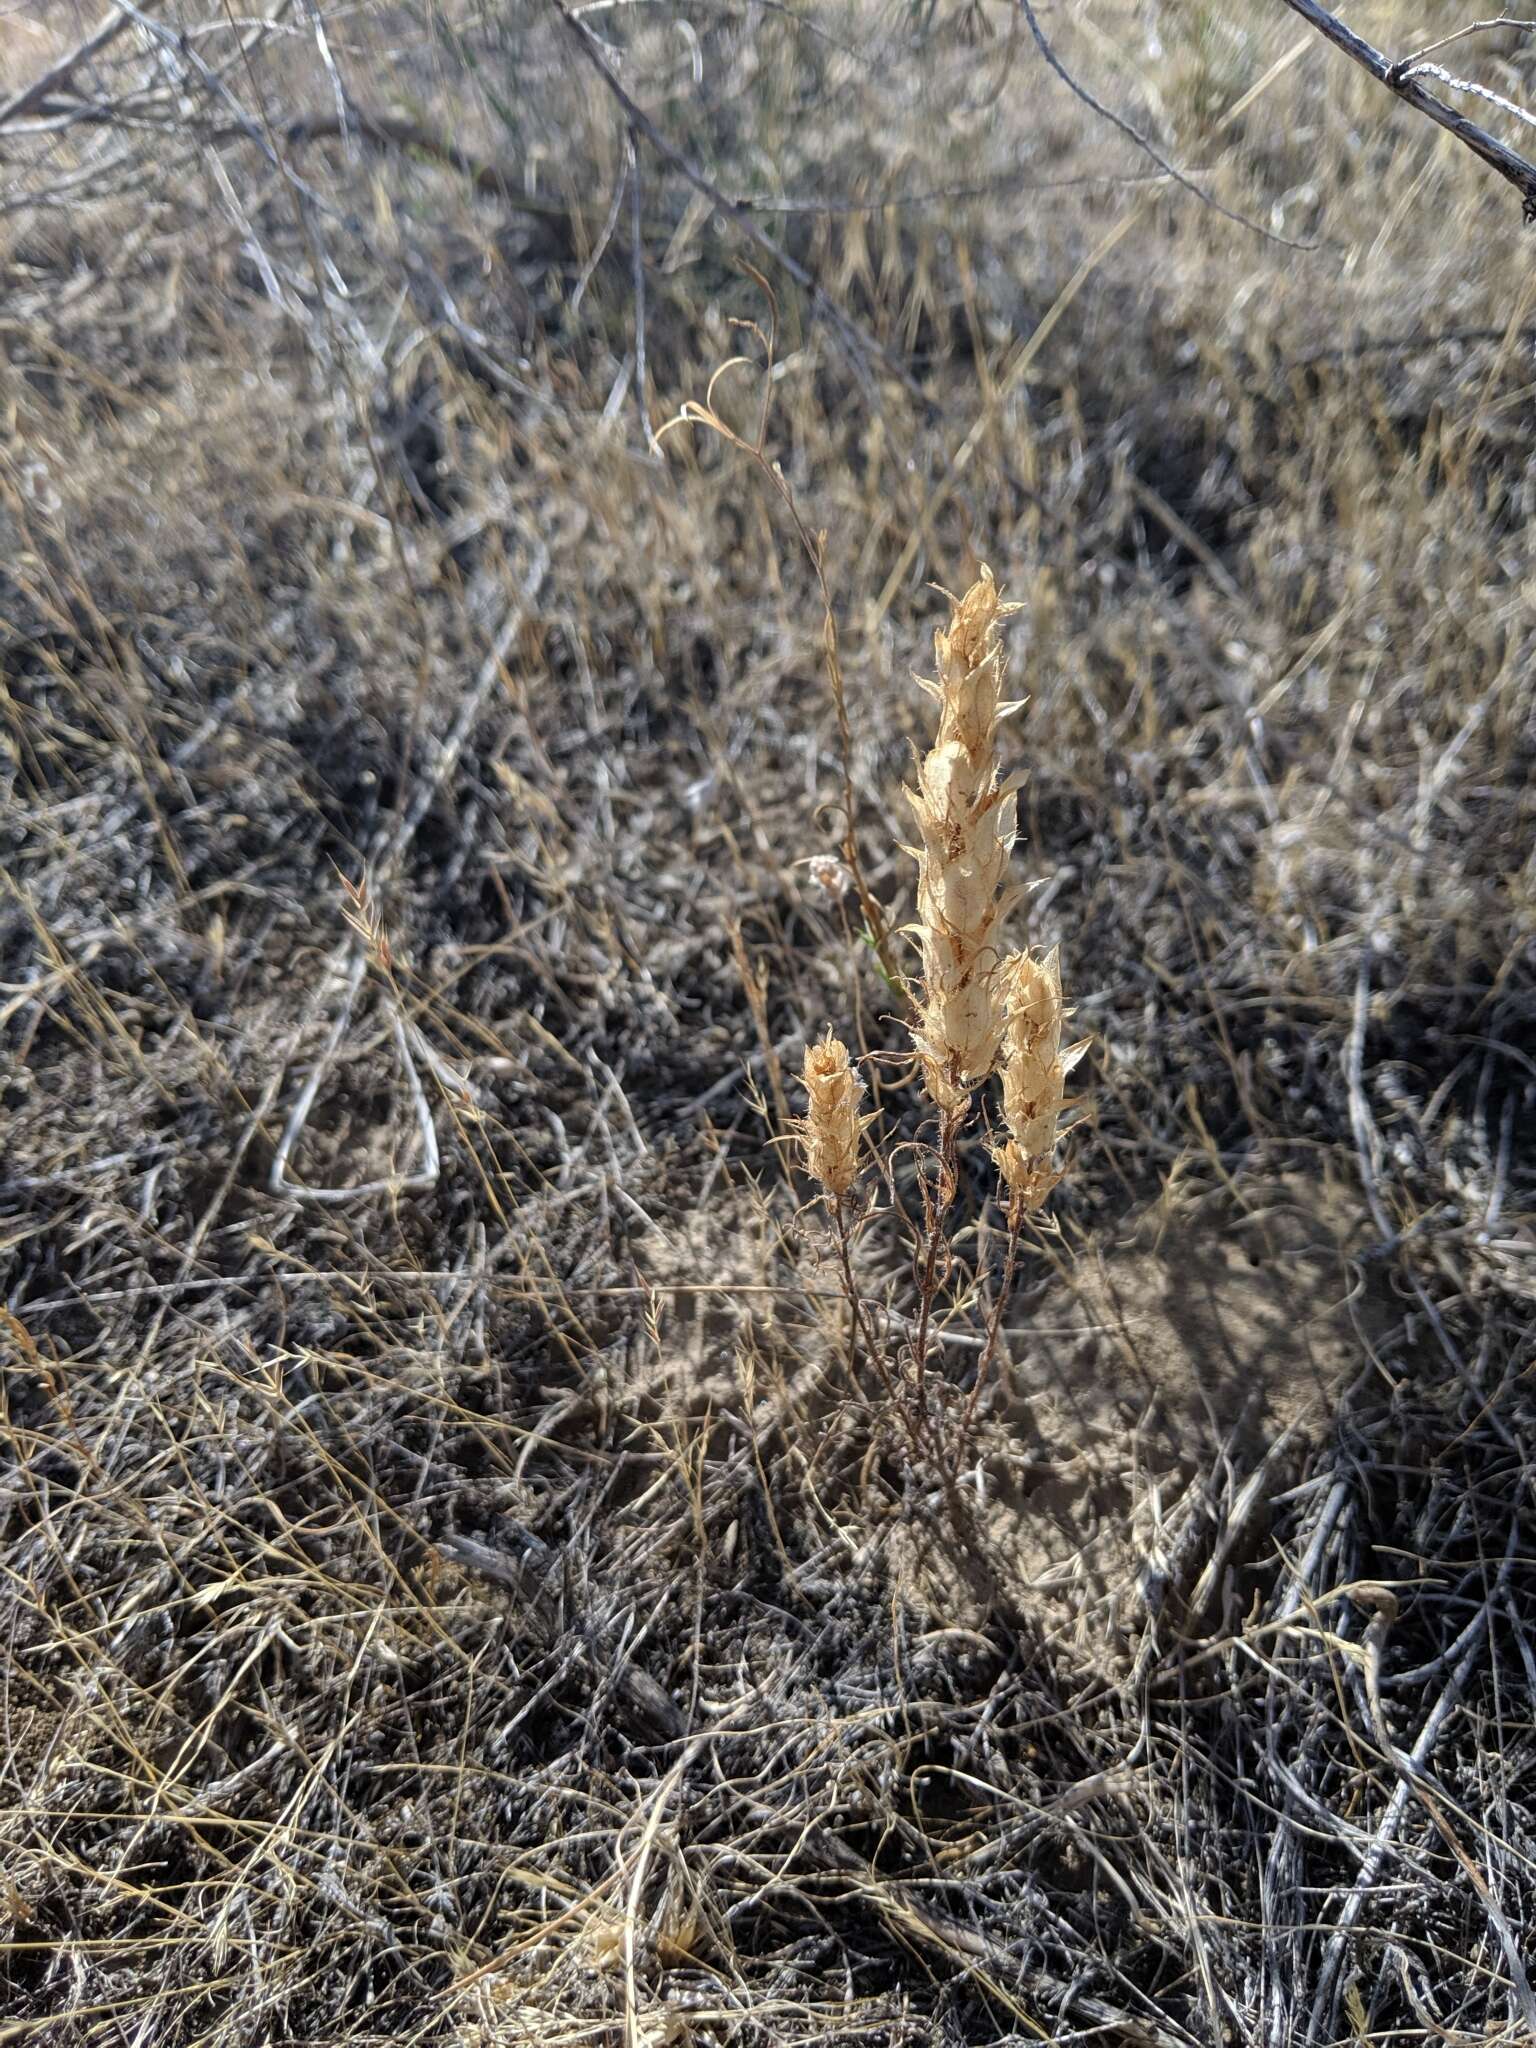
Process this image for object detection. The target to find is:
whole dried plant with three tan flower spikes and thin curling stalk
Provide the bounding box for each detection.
[659,356,1081,1448]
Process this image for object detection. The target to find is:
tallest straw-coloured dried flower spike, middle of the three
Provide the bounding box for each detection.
[907,567,1018,1112]
